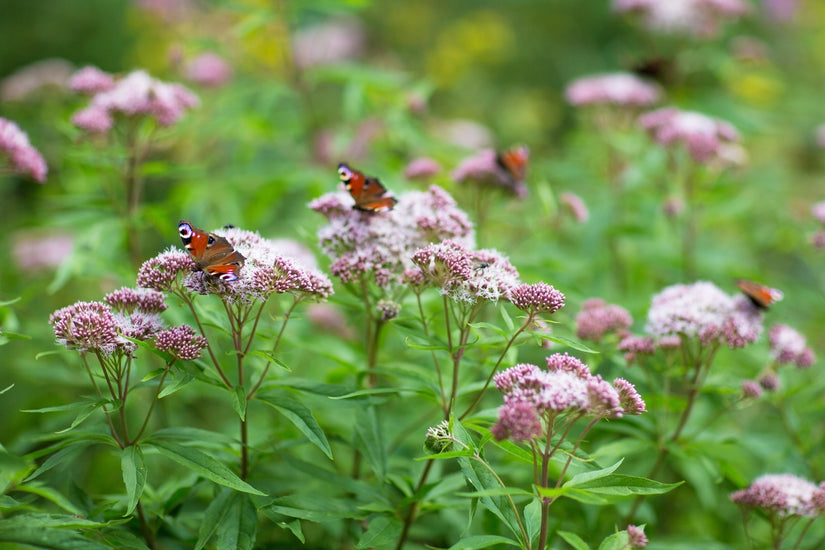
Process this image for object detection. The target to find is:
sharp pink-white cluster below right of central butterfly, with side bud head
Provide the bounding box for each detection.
[408,240,520,309]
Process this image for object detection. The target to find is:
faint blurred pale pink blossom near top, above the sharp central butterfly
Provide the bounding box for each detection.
[292,19,366,68]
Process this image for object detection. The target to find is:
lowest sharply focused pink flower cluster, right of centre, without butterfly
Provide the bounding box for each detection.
[491,353,646,441]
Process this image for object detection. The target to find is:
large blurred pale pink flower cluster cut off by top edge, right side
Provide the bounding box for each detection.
[613,0,750,37]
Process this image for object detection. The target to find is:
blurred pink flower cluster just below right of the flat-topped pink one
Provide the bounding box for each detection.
[639,107,740,164]
